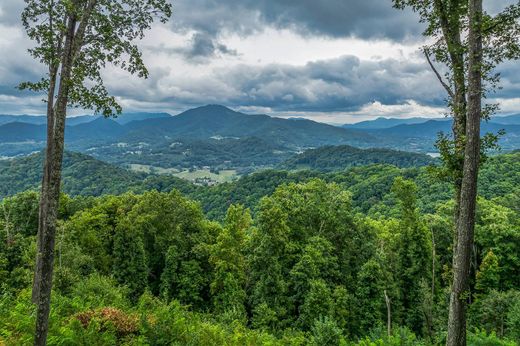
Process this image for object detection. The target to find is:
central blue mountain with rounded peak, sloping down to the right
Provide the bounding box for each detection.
[121,105,377,147]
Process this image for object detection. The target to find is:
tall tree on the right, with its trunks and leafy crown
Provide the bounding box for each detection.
[394,0,520,345]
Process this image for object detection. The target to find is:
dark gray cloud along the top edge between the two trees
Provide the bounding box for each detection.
[172,0,423,40]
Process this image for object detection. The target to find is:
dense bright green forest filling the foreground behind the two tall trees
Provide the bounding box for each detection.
[0,177,520,345]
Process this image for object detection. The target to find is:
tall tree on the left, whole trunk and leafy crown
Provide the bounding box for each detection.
[20,0,171,345]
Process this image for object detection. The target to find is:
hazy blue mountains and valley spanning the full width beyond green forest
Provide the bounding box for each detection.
[0,105,520,174]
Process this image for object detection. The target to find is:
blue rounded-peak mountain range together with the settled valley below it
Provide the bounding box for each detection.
[0,105,378,171]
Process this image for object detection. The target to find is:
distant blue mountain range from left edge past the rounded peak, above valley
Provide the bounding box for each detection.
[0,105,377,148]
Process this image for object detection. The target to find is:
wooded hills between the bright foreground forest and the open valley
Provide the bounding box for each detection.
[0,151,520,220]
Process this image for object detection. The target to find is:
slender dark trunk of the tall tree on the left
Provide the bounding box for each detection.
[33,14,76,346]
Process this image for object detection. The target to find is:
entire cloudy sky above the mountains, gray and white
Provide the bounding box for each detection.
[0,0,520,123]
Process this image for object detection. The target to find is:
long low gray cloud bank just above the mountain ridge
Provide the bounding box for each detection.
[100,56,444,112]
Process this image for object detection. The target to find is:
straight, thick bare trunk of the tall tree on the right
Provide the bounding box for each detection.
[446,0,482,346]
